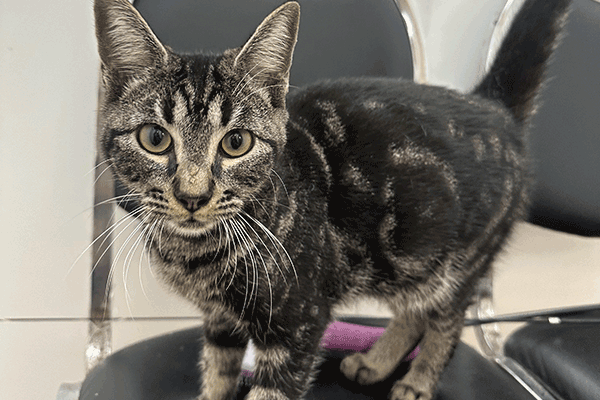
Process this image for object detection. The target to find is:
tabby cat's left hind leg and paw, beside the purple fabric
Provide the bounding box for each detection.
[340,315,425,385]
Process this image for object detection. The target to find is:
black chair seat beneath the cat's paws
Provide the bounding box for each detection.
[79,318,532,400]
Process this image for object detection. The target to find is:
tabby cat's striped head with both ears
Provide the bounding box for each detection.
[94,0,300,237]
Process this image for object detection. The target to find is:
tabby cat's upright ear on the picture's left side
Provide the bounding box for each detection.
[94,0,169,81]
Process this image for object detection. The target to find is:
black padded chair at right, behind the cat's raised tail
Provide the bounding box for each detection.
[504,0,600,400]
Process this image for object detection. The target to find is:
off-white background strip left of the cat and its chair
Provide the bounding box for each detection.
[0,0,97,400]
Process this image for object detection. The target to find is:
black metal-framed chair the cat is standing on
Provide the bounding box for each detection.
[59,0,596,400]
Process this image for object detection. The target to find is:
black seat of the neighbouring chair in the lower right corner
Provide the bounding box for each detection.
[505,310,600,400]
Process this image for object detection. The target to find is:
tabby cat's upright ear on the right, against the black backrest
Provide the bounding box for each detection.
[234,1,300,100]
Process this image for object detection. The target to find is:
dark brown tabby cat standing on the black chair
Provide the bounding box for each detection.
[95,0,568,400]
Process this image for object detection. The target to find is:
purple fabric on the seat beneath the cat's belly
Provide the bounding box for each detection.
[242,321,419,377]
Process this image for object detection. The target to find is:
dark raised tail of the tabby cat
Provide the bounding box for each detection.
[474,0,571,123]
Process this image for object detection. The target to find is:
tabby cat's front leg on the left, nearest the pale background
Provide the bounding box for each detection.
[198,318,248,400]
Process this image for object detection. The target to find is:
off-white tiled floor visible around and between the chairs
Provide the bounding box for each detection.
[0,0,600,400]
